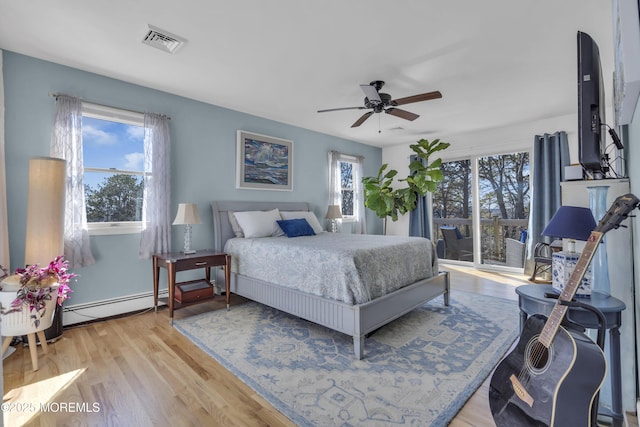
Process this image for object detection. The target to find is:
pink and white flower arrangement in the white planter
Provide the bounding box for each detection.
[11,255,77,327]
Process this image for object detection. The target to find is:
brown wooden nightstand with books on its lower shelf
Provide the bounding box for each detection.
[152,250,231,324]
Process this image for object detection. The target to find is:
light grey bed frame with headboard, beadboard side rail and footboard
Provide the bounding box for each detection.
[211,201,449,359]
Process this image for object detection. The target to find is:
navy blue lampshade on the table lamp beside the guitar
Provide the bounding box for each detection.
[542,206,596,240]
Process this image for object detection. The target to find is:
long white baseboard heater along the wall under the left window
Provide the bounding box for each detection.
[62,290,167,326]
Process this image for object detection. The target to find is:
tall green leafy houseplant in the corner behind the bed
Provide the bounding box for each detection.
[362,139,450,231]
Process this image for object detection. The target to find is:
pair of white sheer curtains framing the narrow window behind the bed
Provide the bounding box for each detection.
[329,151,367,234]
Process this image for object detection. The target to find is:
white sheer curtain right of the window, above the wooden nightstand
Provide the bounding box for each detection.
[140,113,171,258]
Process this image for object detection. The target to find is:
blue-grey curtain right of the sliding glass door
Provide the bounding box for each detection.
[525,131,570,273]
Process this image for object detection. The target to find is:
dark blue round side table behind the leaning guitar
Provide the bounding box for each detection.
[516,285,626,427]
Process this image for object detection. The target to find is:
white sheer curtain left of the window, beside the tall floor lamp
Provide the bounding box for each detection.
[51,95,95,268]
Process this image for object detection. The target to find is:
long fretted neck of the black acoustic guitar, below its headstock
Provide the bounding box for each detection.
[539,231,604,348]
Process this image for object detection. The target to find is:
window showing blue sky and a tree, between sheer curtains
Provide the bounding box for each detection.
[82,103,144,234]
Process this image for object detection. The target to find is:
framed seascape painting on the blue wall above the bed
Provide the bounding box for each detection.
[236,130,293,191]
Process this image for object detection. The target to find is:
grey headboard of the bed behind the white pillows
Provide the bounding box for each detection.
[211,201,311,251]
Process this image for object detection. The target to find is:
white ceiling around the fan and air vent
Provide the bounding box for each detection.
[0,0,613,150]
